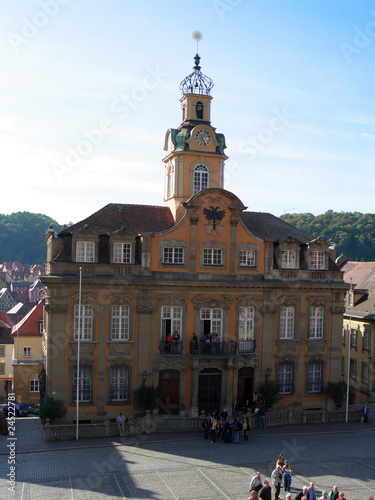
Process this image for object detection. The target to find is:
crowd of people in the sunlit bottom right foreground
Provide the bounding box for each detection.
[248,454,374,500]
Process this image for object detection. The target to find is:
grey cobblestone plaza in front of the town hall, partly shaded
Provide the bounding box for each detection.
[0,418,375,500]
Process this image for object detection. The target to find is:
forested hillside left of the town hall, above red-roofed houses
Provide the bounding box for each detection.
[0,212,61,264]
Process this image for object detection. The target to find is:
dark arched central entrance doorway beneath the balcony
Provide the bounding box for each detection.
[198,368,221,413]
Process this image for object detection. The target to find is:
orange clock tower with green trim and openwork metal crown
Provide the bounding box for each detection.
[163,54,227,222]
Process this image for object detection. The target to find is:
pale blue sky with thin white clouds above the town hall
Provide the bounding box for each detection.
[0,0,375,224]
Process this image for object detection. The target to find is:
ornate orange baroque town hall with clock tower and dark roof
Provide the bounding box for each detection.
[41,55,347,422]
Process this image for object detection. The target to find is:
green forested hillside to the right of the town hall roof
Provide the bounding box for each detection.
[280,210,375,261]
